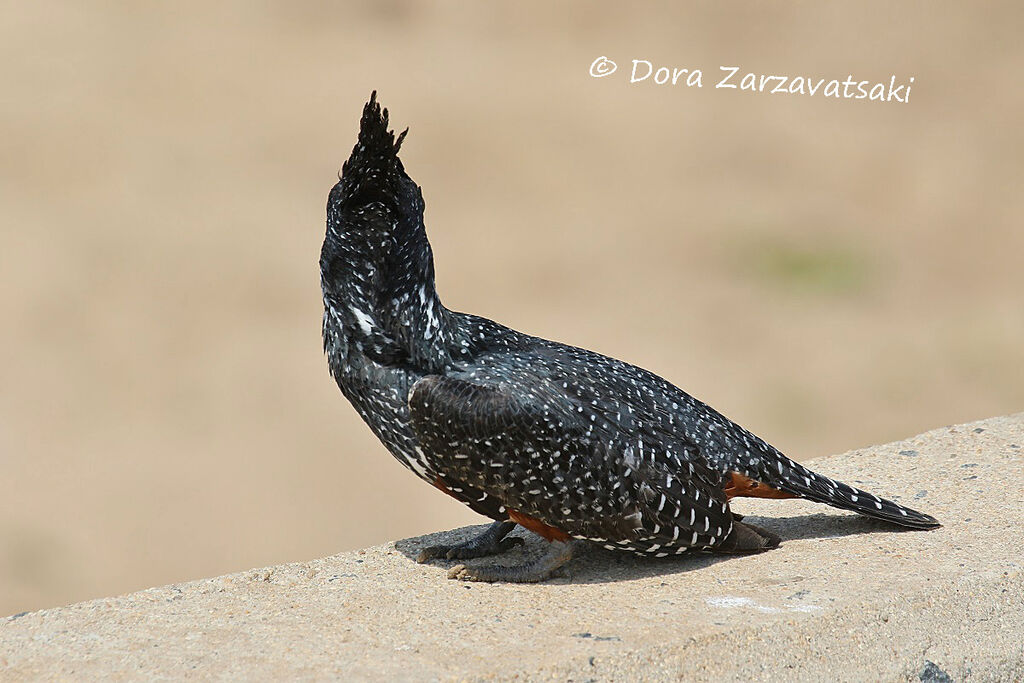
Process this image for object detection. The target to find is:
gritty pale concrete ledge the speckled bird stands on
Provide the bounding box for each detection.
[0,414,1024,681]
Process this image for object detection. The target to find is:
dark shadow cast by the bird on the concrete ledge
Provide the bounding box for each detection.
[395,513,910,585]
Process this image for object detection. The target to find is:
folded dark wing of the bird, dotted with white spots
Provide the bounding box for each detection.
[409,375,732,552]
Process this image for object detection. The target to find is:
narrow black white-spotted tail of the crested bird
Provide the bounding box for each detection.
[761,454,941,529]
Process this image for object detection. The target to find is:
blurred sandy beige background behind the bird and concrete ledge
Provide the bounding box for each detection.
[0,1,1024,614]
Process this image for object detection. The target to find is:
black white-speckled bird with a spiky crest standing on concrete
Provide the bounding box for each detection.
[319,91,940,583]
